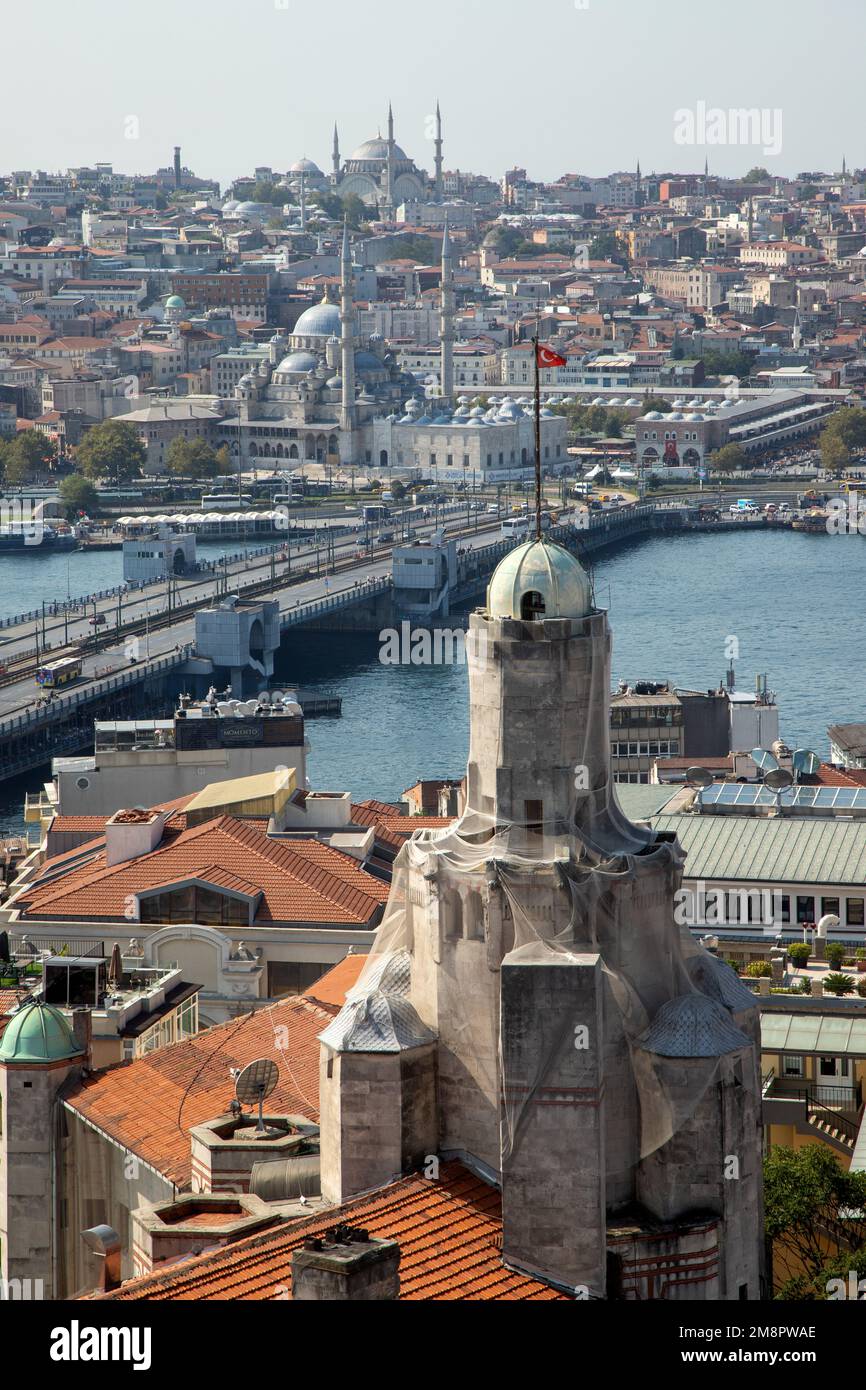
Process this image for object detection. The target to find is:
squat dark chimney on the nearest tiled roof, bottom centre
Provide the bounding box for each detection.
[292,1226,400,1302]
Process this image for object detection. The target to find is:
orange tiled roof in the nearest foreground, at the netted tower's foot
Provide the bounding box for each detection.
[101,1163,567,1302]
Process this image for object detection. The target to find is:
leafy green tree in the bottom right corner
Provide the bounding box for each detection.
[763,1144,866,1300]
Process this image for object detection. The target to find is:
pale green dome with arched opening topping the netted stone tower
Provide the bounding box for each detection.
[487,541,592,620]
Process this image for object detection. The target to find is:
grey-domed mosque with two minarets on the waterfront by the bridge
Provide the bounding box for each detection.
[217,214,567,484]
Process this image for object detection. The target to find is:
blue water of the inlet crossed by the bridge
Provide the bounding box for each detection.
[0,531,866,826]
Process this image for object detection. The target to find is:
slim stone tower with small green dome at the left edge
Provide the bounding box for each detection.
[0,1002,86,1298]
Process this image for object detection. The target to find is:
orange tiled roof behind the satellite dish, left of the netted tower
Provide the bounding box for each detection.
[65,995,335,1191]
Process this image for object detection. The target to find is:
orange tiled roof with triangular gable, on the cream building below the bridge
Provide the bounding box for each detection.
[15,816,388,927]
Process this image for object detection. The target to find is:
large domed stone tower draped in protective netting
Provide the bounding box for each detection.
[321,541,763,1300]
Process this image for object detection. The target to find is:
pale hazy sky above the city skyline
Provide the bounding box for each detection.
[0,0,866,183]
